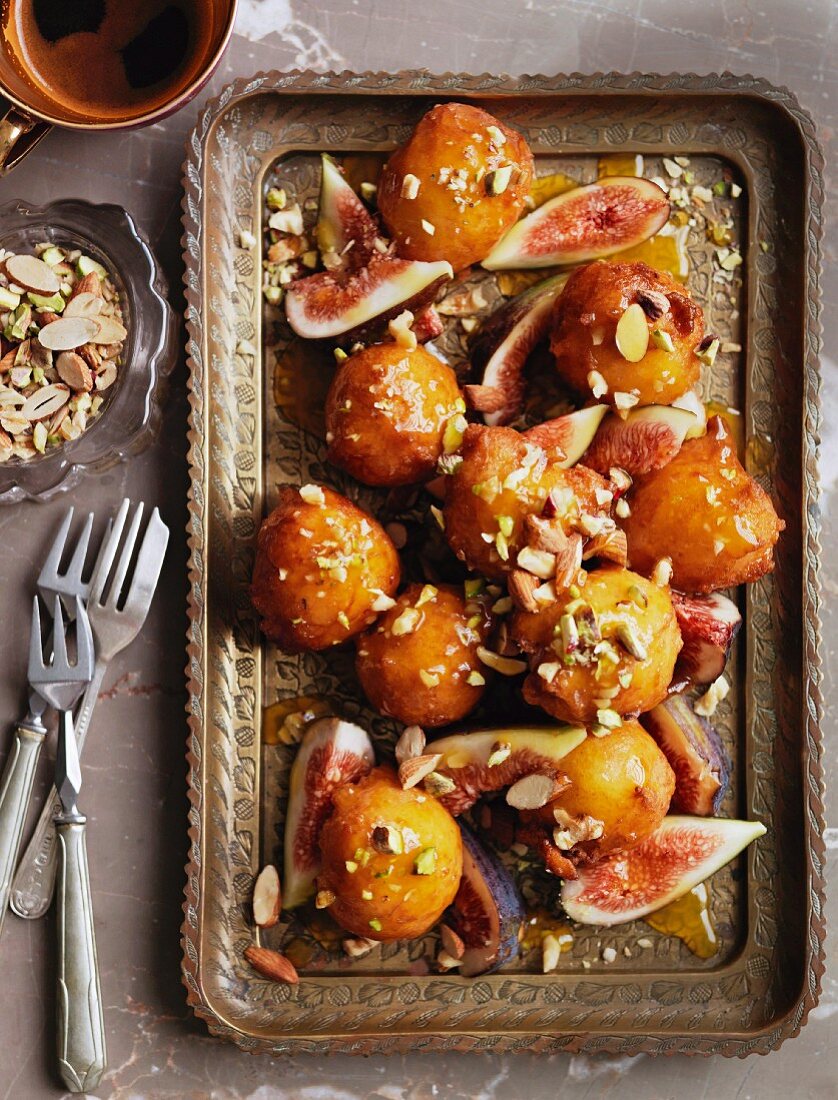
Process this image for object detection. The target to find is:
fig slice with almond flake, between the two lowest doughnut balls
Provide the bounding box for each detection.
[426,726,585,816]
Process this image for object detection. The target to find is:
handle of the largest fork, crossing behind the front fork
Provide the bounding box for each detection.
[10,661,108,920]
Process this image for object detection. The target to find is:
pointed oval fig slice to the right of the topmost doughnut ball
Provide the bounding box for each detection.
[483,176,670,271]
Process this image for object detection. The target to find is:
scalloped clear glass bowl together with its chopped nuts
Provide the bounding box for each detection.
[0,200,176,503]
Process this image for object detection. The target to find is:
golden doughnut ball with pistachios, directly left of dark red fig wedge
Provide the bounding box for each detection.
[510,565,682,726]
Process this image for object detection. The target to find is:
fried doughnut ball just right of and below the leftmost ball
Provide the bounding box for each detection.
[355,584,490,727]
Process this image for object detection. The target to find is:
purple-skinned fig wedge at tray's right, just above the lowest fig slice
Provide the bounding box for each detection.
[640,695,730,817]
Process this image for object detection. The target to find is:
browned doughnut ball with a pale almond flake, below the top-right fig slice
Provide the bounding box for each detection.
[550,260,704,407]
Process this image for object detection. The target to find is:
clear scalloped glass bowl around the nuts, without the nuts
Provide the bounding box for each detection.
[0,199,177,504]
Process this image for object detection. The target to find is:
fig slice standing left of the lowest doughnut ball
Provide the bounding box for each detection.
[283,717,375,909]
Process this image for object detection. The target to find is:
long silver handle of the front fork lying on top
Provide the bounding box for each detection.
[56,814,107,1092]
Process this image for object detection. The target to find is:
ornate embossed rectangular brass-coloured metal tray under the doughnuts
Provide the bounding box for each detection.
[183,73,824,1055]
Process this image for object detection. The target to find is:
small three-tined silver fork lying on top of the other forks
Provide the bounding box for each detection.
[29,595,106,1092]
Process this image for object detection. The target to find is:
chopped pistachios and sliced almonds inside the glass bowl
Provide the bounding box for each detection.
[0,242,128,462]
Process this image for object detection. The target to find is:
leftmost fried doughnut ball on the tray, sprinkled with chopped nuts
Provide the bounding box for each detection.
[251,485,399,653]
